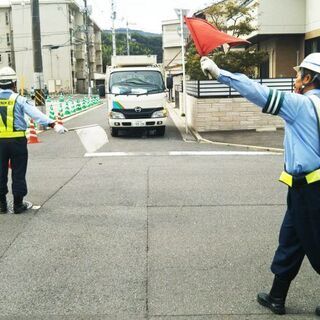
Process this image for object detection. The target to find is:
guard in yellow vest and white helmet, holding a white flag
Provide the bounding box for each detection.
[0,67,66,214]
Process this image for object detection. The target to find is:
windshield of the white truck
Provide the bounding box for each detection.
[110,70,164,95]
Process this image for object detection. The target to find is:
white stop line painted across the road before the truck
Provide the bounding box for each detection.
[84,151,282,158]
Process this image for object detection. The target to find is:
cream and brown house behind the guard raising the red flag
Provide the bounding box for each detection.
[196,0,320,78]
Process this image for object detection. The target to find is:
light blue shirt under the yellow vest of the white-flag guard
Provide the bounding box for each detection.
[0,90,53,131]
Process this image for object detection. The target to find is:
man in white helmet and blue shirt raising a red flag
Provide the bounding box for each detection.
[201,53,320,316]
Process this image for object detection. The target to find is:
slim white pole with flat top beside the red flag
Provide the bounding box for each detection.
[174,9,189,133]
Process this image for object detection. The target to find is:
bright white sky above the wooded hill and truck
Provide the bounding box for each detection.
[77,0,213,33]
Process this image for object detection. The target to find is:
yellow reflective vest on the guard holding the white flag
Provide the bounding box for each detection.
[0,93,26,139]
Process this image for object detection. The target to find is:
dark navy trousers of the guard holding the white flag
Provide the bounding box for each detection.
[0,137,28,197]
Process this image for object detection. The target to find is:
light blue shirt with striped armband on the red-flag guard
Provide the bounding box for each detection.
[217,70,320,175]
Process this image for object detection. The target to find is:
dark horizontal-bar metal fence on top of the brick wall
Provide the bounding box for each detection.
[184,78,294,98]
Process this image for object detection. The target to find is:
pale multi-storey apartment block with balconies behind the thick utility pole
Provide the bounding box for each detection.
[0,0,103,93]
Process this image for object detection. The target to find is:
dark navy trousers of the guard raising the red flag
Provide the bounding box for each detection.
[271,182,320,280]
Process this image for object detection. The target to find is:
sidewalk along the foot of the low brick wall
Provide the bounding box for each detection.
[168,103,284,151]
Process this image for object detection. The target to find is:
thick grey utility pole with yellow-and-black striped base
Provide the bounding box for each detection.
[31,0,46,113]
